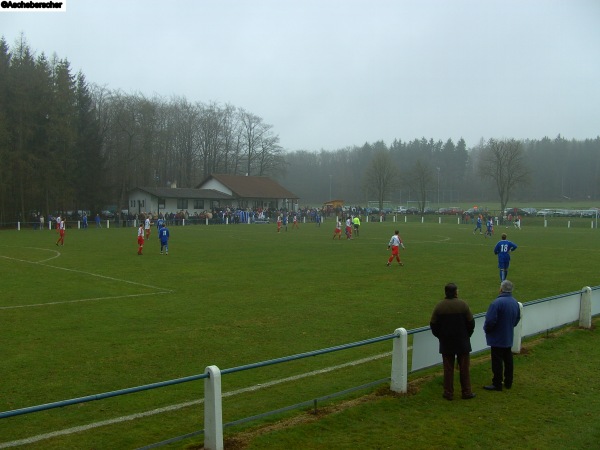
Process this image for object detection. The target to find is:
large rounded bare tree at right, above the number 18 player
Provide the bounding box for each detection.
[478,139,530,218]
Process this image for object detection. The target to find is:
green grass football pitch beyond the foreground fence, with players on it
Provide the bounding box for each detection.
[0,216,600,449]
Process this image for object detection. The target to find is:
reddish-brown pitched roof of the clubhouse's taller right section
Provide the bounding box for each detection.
[198,174,299,199]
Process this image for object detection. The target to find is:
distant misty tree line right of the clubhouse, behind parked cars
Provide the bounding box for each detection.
[280,135,600,210]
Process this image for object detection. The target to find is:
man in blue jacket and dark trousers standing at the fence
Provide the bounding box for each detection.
[483,280,521,391]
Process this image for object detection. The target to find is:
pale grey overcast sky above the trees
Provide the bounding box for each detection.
[0,0,600,151]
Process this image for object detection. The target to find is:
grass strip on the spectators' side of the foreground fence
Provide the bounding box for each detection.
[229,320,600,450]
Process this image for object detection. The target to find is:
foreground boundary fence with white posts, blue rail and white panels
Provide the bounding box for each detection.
[0,286,600,450]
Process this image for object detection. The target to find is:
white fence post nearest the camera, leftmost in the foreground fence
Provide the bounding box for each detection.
[204,366,223,450]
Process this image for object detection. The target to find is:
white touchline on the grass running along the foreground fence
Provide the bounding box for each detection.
[0,352,392,449]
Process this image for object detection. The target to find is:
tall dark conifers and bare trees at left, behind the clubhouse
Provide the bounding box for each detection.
[0,35,285,223]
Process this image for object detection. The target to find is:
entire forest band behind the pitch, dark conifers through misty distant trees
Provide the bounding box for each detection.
[0,36,600,224]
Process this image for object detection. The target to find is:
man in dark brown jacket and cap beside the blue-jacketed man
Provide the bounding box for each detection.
[429,283,475,400]
